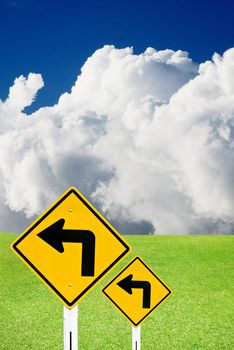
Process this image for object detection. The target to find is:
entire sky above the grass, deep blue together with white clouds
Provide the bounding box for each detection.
[0,0,234,234]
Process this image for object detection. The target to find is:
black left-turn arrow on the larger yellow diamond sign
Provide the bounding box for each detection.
[38,219,95,276]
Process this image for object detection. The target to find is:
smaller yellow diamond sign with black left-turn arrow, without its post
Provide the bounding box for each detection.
[102,257,171,327]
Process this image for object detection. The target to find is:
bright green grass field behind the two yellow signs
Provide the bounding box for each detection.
[0,233,234,350]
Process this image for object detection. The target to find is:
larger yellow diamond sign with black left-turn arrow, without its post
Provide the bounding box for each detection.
[11,188,130,308]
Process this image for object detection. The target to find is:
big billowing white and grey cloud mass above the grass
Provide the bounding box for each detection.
[0,46,234,234]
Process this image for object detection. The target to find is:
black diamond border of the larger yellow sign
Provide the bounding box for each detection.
[12,188,130,307]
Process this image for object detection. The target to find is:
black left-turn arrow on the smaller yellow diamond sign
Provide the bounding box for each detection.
[117,274,151,309]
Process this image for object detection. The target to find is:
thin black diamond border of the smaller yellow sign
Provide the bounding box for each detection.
[102,256,171,326]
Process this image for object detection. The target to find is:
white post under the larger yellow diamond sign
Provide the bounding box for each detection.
[63,305,78,350]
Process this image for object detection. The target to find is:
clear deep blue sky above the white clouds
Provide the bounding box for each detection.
[0,0,234,111]
